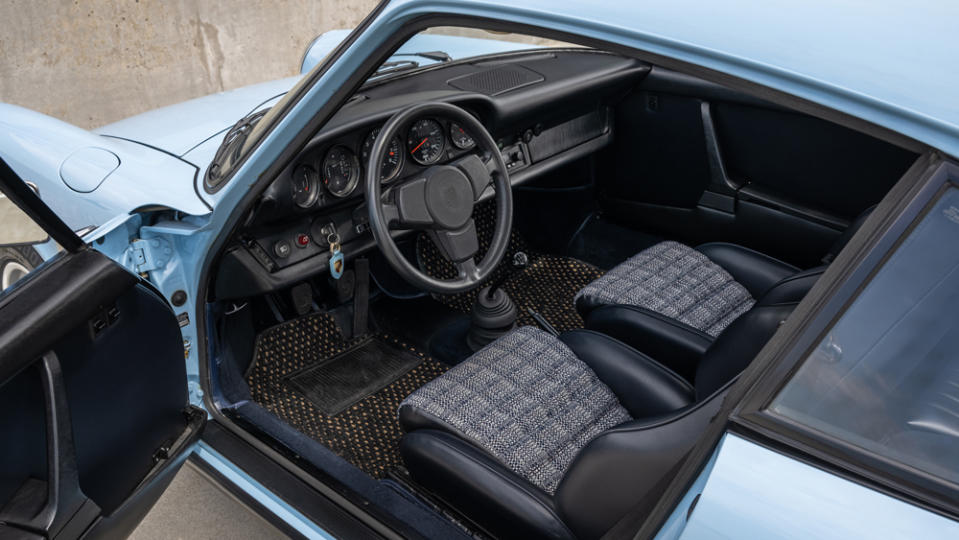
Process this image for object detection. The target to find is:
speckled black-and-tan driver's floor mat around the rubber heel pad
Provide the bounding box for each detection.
[247,314,448,478]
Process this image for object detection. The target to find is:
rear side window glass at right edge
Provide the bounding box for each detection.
[770,188,959,484]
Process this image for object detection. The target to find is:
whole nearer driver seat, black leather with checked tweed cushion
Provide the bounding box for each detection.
[399,304,794,538]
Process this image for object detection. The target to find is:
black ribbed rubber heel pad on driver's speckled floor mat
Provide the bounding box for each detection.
[286,338,423,416]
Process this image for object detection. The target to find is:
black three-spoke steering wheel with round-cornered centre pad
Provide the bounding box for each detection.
[365,102,513,294]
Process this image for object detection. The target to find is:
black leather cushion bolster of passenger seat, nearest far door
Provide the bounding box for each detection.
[696,242,799,298]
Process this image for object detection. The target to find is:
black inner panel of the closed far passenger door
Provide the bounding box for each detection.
[597,68,917,267]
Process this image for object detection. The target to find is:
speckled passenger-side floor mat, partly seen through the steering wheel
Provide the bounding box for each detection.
[416,201,603,332]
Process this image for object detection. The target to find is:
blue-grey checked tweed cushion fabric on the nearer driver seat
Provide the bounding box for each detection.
[400,326,632,494]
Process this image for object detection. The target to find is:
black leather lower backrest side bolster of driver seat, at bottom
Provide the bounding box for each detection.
[555,392,725,538]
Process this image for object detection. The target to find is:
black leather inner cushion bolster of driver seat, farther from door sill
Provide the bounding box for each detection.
[559,330,696,418]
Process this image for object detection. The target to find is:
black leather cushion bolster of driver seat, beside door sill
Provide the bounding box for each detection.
[400,429,573,538]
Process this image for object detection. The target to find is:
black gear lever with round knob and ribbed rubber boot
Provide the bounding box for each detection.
[466,251,529,352]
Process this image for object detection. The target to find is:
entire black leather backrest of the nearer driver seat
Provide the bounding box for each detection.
[555,302,796,538]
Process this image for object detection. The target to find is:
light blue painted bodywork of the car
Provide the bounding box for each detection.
[0,0,959,539]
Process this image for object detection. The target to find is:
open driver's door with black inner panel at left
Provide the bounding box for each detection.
[0,160,206,539]
